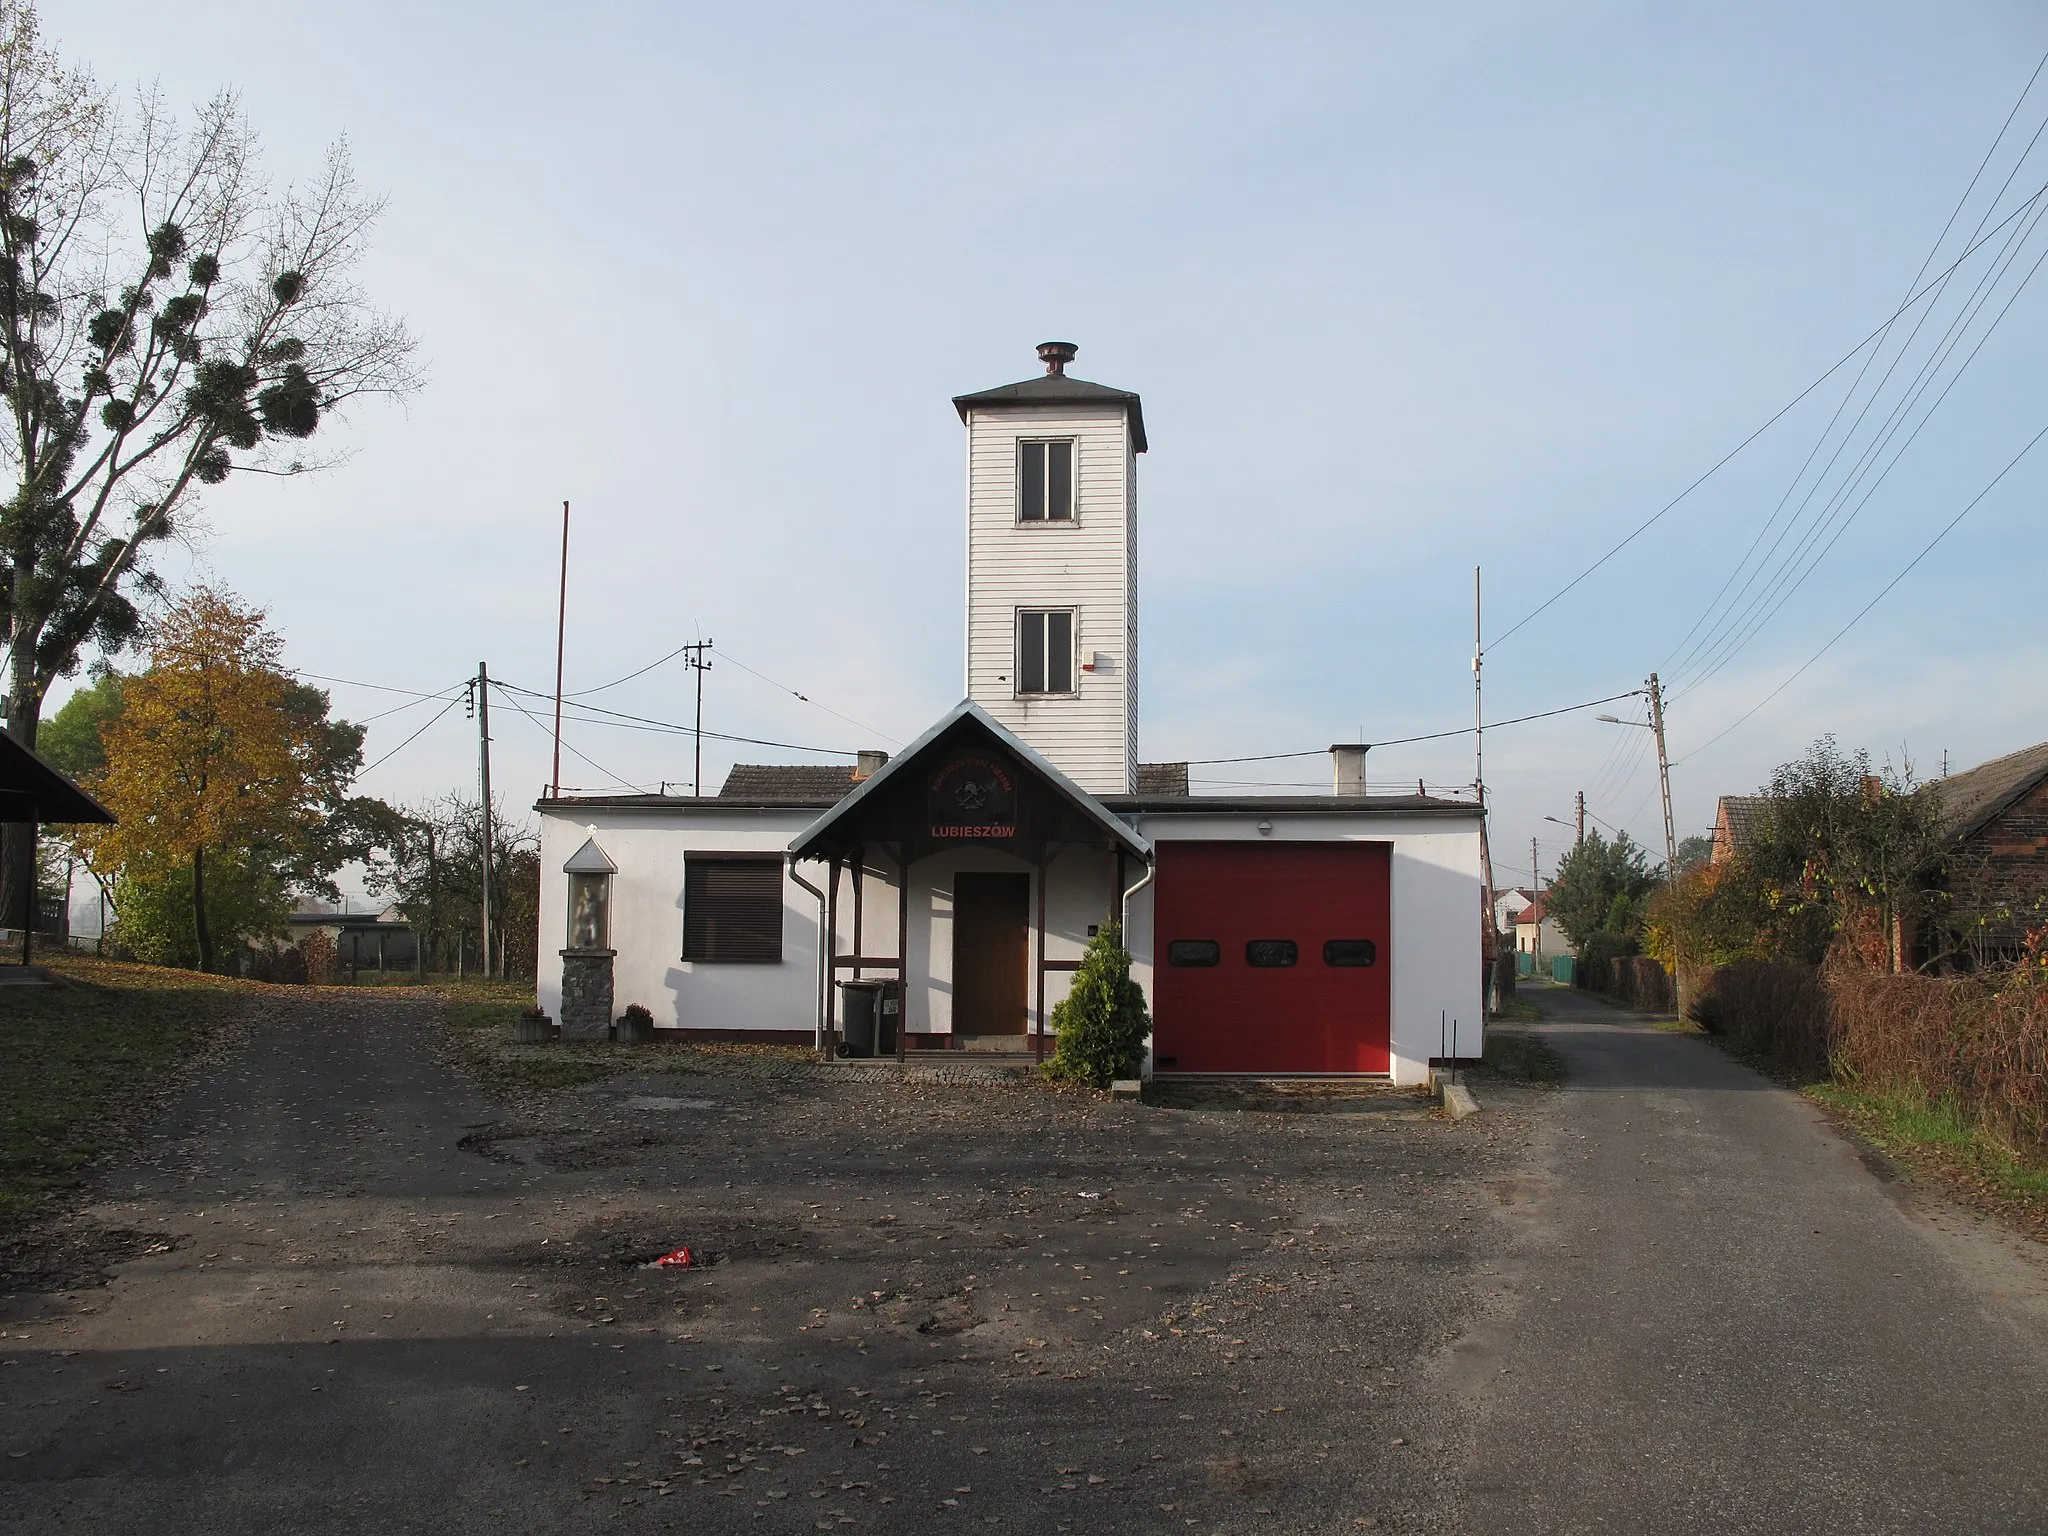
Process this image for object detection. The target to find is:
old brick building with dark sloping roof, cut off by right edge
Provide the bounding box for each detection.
[1917,741,2048,967]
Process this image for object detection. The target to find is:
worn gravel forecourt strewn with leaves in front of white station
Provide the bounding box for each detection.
[0,993,1554,1536]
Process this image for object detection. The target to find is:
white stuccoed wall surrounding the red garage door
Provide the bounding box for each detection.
[1126,811,1485,1083]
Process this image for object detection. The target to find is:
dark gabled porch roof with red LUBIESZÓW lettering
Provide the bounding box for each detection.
[788,698,1151,862]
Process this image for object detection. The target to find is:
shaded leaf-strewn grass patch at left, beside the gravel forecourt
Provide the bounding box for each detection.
[0,956,246,1223]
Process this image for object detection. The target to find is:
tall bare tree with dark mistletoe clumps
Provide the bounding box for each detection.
[0,0,420,924]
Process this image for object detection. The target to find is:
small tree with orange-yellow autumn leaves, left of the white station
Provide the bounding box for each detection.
[86,588,326,971]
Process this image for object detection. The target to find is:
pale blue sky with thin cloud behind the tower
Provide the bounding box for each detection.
[45,2,2048,883]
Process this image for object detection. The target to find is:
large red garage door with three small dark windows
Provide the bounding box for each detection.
[1153,840,1393,1073]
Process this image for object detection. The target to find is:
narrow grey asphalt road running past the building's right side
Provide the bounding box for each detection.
[1450,987,2048,1532]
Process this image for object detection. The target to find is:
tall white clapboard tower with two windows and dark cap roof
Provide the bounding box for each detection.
[952,342,1145,795]
